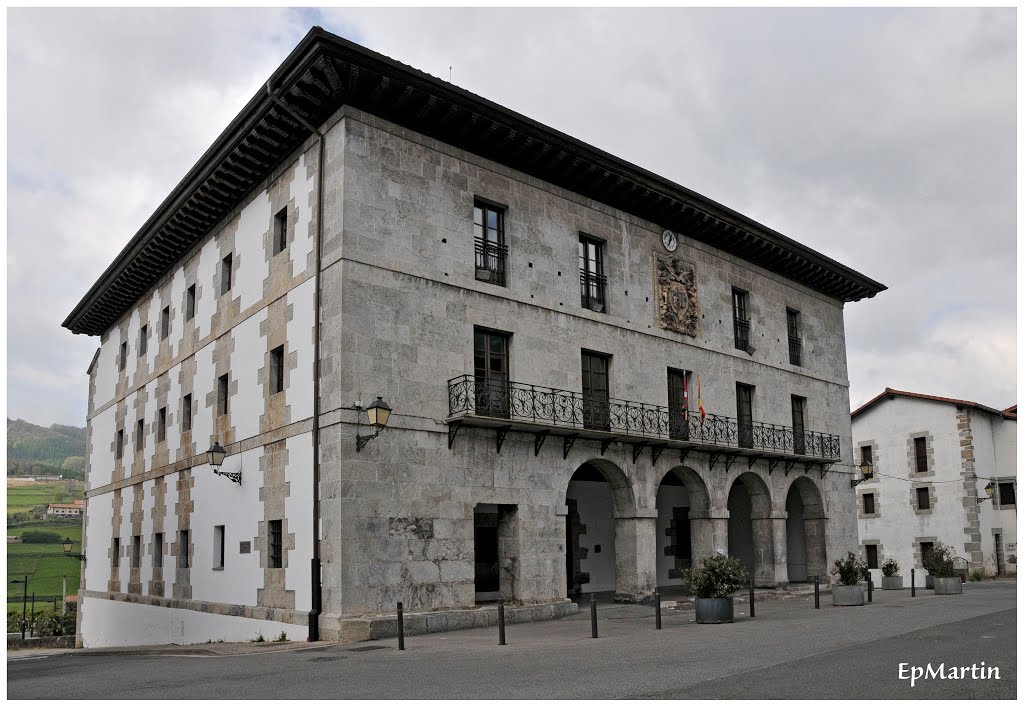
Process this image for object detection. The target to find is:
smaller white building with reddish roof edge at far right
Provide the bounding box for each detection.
[852,388,1017,585]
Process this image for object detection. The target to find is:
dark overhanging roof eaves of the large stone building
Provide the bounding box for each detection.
[63,27,886,335]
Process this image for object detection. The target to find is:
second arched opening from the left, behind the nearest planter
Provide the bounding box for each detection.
[655,466,713,587]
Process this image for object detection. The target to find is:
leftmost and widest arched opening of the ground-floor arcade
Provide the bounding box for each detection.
[565,460,634,598]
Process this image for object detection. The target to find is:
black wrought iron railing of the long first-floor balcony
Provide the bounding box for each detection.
[449,375,840,460]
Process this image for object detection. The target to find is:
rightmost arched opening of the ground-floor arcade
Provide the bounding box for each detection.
[785,476,827,582]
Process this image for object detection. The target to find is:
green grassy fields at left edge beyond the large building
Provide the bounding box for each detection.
[7,482,83,607]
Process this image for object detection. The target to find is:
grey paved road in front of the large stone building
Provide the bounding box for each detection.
[7,582,1017,699]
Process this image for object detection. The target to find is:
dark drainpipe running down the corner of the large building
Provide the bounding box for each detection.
[266,76,324,640]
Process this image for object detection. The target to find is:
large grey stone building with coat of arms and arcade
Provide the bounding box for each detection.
[65,28,885,646]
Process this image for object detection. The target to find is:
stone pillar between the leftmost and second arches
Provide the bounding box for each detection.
[614,508,657,602]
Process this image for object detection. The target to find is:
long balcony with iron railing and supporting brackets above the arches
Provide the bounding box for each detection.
[445,375,841,473]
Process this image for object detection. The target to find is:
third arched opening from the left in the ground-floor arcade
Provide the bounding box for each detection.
[726,472,775,586]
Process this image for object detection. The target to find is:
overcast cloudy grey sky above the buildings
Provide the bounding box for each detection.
[7,8,1017,424]
